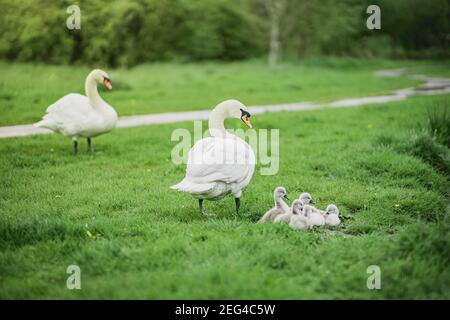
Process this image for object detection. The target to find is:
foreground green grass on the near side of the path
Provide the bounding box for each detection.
[0,93,450,299]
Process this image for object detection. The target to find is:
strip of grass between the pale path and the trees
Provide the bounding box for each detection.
[0,58,450,125]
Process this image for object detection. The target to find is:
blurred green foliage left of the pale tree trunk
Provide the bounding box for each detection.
[0,0,264,66]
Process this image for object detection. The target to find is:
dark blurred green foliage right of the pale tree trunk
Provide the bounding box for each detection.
[279,0,450,58]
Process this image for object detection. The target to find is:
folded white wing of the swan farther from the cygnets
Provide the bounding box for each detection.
[36,93,95,136]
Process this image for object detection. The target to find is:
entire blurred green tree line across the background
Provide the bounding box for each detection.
[0,0,450,66]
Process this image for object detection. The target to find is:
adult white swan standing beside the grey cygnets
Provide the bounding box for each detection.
[171,100,256,213]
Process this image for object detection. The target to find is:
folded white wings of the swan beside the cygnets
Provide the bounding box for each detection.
[186,137,255,183]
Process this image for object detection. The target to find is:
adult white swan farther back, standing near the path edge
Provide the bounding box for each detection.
[35,69,117,154]
